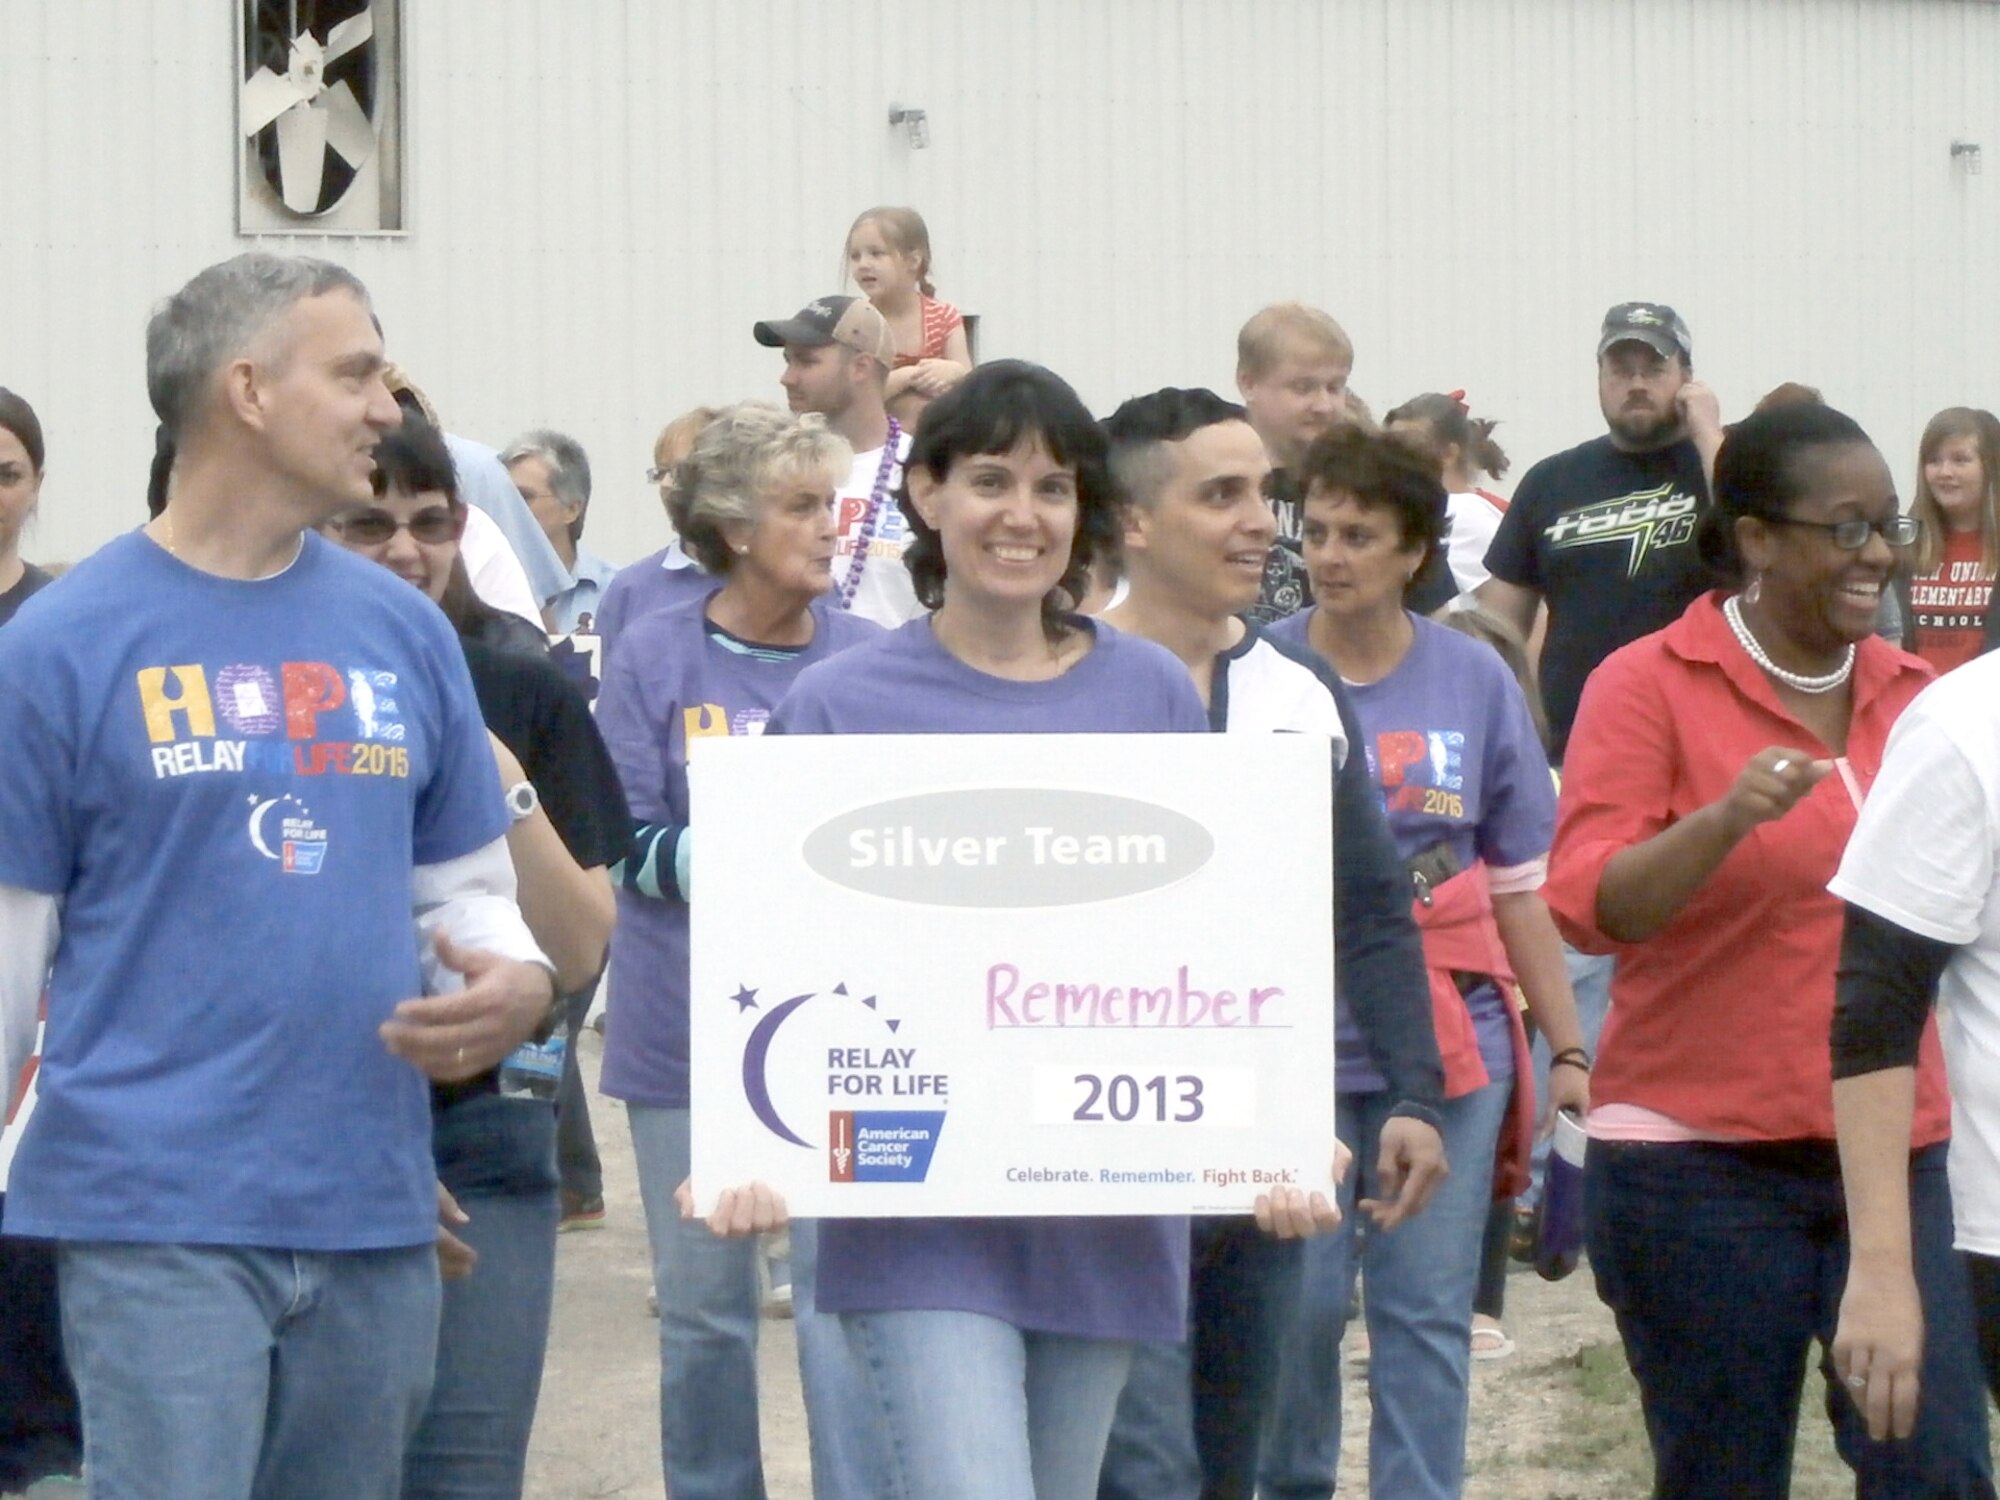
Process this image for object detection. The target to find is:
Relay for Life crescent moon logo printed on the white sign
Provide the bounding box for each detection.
[730,984,950,1182]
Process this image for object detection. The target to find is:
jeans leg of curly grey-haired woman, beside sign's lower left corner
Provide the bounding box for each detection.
[626,1104,764,1500]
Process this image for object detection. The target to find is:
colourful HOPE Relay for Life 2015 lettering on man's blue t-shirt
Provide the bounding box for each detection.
[134,662,410,780]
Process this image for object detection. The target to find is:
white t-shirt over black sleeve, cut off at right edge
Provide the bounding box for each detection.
[1828,654,2000,1256]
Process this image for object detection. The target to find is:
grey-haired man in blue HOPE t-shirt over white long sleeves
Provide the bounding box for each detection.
[0,254,554,1500]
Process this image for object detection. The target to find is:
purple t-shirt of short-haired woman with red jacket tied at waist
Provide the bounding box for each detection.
[1270,610,1556,1080]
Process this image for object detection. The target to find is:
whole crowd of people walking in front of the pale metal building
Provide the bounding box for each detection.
[0,208,2000,1500]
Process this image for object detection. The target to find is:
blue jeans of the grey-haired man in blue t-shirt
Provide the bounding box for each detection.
[58,1244,438,1500]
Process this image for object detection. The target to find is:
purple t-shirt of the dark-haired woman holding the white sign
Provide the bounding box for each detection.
[770,618,1208,1342]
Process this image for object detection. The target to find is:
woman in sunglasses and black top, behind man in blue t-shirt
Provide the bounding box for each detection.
[326,414,630,1500]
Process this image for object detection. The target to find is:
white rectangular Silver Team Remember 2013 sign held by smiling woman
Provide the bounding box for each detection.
[688,734,1334,1218]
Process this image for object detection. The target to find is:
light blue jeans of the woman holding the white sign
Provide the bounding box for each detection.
[840,1310,1132,1500]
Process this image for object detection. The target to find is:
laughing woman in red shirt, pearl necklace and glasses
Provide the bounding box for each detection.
[1548,406,1992,1500]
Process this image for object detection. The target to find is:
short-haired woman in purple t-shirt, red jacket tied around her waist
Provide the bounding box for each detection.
[1262,426,1590,1498]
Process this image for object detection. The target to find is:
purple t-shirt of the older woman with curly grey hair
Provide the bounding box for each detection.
[598,592,882,1110]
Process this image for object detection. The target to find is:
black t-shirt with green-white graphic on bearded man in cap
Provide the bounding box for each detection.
[1486,438,1710,762]
